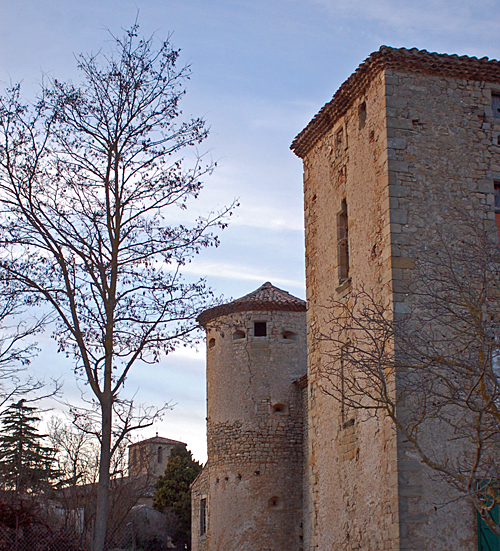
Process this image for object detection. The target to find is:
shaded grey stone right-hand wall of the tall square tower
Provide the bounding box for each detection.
[374,70,500,551]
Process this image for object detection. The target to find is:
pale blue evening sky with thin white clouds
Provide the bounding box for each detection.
[0,0,500,461]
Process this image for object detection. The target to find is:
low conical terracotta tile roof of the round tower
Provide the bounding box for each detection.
[198,281,306,325]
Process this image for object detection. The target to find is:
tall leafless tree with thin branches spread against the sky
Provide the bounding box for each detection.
[0,25,231,551]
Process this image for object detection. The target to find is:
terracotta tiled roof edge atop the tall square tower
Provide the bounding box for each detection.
[290,46,500,158]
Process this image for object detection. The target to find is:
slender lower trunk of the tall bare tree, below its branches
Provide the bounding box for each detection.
[93,399,112,551]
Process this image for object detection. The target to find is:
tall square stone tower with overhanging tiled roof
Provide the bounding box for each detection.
[292,46,500,551]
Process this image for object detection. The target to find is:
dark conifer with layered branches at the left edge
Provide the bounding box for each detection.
[0,400,57,492]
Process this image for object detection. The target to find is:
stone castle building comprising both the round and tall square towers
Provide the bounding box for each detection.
[192,46,500,551]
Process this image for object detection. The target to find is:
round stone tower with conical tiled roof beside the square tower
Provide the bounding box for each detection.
[192,283,306,551]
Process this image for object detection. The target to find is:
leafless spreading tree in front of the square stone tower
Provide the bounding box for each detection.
[314,212,500,534]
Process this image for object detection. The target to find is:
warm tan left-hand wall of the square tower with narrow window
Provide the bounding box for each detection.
[298,69,399,551]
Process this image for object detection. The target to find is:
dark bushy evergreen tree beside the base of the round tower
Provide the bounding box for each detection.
[153,445,202,549]
